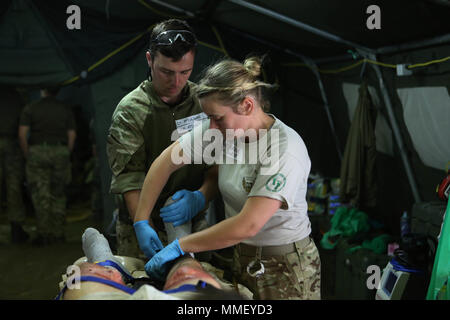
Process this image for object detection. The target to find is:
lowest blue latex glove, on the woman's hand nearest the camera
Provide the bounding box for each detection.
[145,239,184,281]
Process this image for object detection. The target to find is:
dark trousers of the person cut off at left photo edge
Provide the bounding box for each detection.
[0,137,26,223]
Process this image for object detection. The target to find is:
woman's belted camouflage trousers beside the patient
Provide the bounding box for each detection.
[233,237,320,300]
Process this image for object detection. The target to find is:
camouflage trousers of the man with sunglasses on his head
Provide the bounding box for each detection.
[116,213,209,261]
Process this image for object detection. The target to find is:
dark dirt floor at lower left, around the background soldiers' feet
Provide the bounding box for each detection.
[0,203,101,300]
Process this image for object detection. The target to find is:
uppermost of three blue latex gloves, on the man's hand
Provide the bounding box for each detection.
[160,189,206,227]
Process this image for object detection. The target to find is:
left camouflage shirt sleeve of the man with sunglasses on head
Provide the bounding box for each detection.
[106,90,149,193]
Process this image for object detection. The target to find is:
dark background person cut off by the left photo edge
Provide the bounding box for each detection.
[0,87,28,243]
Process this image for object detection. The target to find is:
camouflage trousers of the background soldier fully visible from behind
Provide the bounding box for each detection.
[26,145,71,237]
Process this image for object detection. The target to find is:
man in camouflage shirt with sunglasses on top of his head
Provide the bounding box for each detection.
[107,19,211,257]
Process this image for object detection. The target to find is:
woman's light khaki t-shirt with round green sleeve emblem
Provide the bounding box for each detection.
[178,116,311,246]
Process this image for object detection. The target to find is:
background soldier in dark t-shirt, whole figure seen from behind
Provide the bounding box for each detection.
[19,88,76,245]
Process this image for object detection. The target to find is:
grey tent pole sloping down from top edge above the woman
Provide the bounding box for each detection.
[228,0,373,52]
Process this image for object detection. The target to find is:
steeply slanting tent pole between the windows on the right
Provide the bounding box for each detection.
[370,54,421,203]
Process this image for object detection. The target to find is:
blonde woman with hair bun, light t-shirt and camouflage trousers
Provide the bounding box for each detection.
[135,58,320,299]
